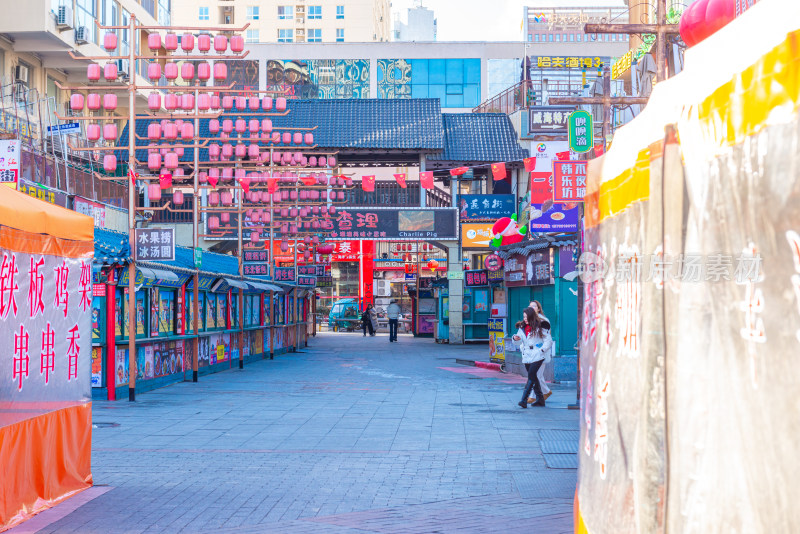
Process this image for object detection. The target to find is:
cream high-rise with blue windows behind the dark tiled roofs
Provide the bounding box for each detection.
[172,0,391,43]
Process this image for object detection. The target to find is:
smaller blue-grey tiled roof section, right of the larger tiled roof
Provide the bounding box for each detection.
[428,113,528,163]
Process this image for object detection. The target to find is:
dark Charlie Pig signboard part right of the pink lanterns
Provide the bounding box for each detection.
[321,208,458,241]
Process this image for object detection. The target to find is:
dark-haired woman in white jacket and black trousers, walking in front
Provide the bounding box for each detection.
[512,308,553,408]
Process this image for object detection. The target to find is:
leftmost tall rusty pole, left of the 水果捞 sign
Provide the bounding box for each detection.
[128,13,138,402]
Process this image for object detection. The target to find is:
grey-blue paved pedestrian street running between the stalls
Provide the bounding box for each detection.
[11,333,578,534]
